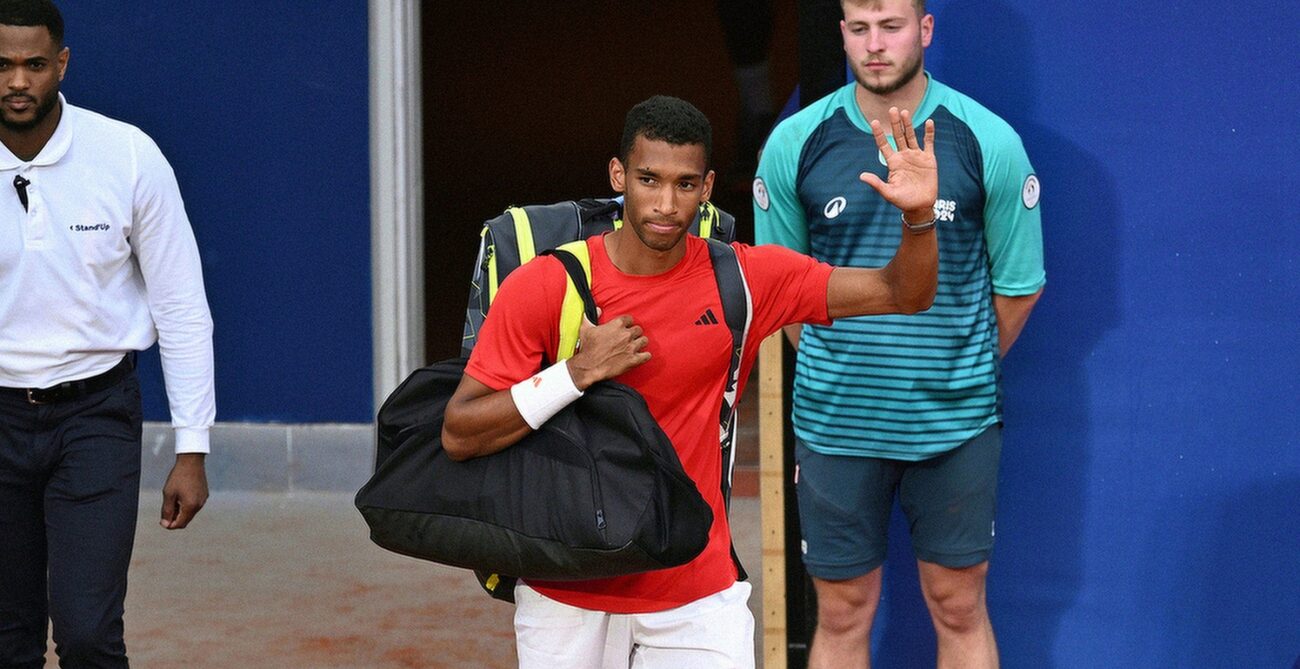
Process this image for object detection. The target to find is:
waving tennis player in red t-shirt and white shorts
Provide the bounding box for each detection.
[443,96,939,669]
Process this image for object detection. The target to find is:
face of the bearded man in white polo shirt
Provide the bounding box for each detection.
[0,25,68,131]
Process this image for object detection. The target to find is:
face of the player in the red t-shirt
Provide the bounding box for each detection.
[610,135,714,252]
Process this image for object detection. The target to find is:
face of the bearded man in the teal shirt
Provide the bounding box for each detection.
[840,0,935,95]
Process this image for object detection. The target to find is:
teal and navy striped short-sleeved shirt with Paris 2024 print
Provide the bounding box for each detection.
[754,73,1047,460]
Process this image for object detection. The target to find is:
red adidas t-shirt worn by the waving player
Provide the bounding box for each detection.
[465,236,832,613]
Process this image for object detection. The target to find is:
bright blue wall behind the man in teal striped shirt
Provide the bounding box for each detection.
[875,0,1300,668]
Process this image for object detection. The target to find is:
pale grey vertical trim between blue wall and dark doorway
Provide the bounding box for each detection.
[369,0,425,409]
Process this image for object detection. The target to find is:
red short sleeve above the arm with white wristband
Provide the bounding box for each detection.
[465,256,564,390]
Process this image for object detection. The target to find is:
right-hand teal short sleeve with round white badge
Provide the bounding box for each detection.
[980,126,1047,296]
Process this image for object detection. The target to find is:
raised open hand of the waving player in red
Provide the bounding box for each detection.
[858,107,939,218]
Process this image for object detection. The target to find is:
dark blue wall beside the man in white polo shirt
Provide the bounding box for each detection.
[59,0,373,422]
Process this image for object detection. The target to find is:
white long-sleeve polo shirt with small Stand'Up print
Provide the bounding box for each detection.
[0,94,216,453]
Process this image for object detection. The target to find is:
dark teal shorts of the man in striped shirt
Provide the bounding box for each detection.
[794,425,1002,581]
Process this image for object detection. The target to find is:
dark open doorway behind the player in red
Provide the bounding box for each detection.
[421,0,797,360]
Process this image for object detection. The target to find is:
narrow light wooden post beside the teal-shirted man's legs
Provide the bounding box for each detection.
[758,331,788,669]
